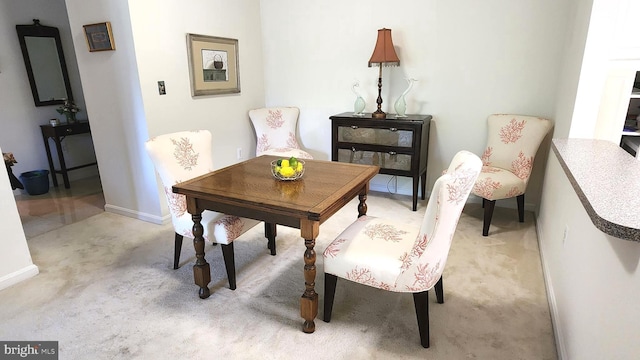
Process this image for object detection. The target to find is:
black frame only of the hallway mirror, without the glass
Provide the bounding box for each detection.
[16,19,73,106]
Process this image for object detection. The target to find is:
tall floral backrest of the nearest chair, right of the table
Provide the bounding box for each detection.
[396,150,482,292]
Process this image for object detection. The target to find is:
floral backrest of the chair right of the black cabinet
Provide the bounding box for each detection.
[482,114,551,183]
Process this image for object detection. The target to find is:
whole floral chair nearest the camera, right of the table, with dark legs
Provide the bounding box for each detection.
[323,151,482,347]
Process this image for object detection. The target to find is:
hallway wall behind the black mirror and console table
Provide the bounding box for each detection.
[0,0,98,193]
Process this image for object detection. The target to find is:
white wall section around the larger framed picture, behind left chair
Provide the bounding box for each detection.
[130,0,264,167]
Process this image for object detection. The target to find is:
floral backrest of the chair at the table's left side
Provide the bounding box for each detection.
[145,130,213,222]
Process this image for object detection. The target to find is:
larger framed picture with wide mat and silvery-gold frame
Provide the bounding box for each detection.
[187,34,240,96]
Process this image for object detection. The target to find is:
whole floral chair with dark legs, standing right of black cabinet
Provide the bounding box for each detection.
[472,114,551,236]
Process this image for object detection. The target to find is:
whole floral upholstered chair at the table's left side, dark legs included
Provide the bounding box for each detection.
[145,130,275,290]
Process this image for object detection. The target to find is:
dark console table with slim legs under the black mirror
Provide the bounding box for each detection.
[40,121,97,189]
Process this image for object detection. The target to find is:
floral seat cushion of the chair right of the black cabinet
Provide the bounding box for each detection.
[473,166,527,200]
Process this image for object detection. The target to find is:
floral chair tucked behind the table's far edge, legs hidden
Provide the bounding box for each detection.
[249,107,313,159]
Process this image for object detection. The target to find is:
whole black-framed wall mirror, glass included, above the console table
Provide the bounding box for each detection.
[16,19,73,106]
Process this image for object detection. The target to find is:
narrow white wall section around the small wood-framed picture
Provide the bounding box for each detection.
[66,0,162,222]
